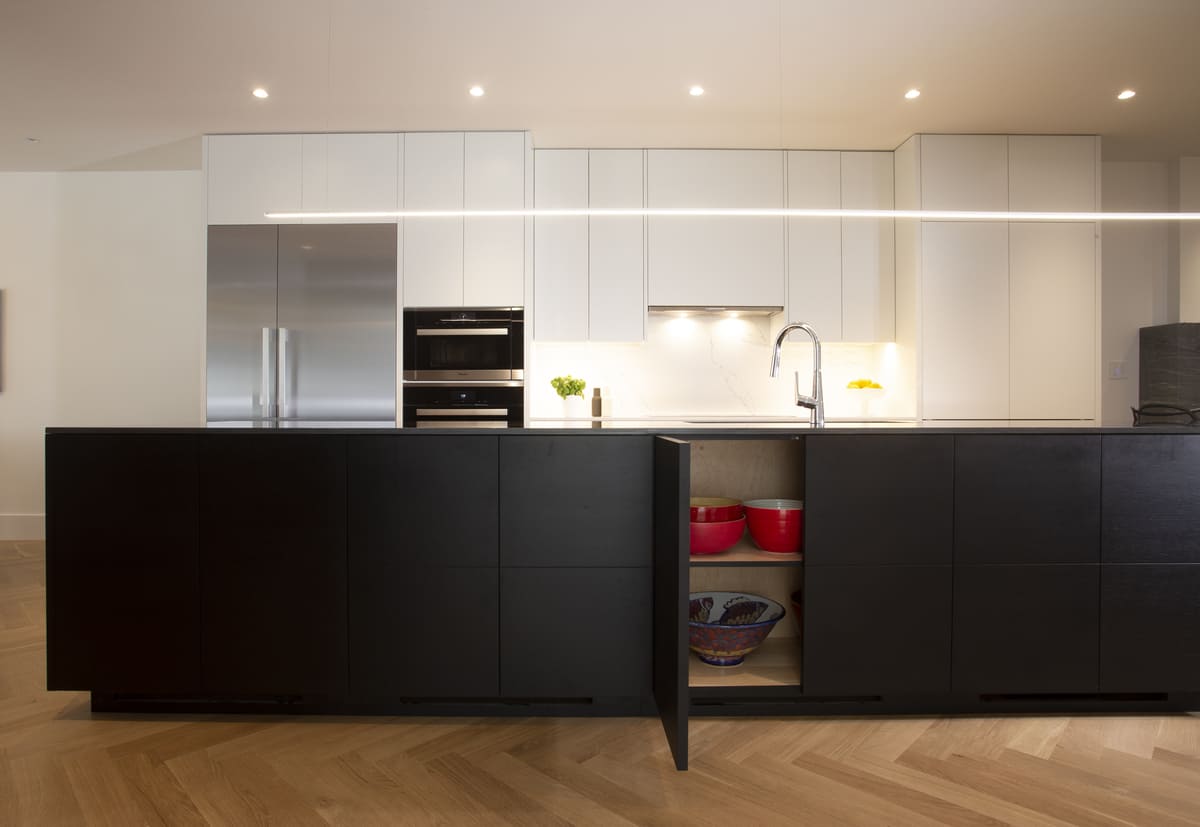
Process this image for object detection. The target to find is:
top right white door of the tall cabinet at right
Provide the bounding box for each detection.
[1008,134,1099,212]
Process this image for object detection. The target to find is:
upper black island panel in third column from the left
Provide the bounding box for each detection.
[349,435,499,567]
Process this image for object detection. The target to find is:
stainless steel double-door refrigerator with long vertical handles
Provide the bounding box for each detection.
[208,224,396,427]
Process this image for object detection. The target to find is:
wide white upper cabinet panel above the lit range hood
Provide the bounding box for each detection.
[646,150,787,307]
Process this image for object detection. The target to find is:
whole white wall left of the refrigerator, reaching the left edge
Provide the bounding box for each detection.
[0,172,204,539]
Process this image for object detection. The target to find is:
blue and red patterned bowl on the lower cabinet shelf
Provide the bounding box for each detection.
[688,592,787,666]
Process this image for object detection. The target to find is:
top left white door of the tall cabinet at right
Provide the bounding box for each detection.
[920,134,1008,210]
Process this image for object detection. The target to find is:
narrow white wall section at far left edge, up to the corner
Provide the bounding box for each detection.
[0,173,58,539]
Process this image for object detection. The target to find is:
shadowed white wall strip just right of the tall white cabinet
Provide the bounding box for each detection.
[1100,162,1171,425]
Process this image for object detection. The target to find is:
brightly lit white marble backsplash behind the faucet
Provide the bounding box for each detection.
[526,314,916,419]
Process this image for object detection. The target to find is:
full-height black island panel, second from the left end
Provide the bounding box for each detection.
[200,433,347,695]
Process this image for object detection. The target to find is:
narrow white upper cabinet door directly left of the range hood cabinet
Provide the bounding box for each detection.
[588,149,646,342]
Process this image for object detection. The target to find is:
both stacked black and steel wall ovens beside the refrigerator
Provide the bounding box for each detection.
[402,307,524,429]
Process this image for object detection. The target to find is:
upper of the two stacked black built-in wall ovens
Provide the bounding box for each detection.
[404,307,524,382]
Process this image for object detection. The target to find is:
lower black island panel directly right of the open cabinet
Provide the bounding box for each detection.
[804,564,952,696]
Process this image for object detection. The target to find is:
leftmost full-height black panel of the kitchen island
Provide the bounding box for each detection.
[46,433,200,693]
